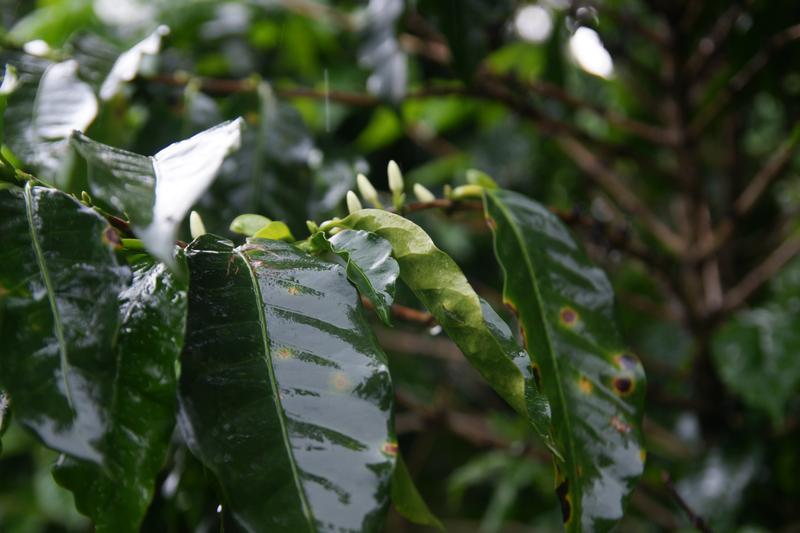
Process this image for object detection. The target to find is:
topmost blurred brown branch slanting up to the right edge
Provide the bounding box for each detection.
[689,24,800,137]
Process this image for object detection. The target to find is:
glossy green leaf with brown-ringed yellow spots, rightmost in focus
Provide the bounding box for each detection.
[485,190,645,531]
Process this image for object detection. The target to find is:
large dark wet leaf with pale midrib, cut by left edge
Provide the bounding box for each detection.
[0,183,129,458]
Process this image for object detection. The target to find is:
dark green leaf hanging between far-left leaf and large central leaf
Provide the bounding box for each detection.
[54,254,186,533]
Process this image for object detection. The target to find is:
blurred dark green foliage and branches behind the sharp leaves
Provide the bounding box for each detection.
[0,0,800,533]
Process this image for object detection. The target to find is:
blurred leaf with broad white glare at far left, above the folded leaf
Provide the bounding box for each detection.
[5,55,98,184]
